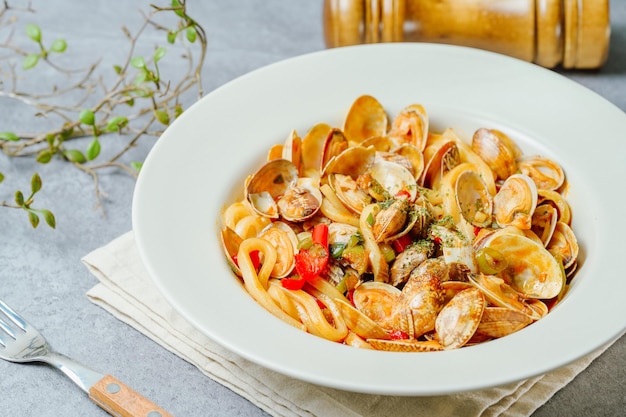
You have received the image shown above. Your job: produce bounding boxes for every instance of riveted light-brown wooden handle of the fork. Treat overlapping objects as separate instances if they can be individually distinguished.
[89,375,173,417]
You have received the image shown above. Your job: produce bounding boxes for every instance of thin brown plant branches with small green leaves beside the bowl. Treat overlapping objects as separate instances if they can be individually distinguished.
[0,0,207,227]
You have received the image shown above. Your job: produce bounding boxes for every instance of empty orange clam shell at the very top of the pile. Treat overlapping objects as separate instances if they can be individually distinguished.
[343,95,389,143]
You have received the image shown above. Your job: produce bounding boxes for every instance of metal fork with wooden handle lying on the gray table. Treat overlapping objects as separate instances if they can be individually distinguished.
[0,300,172,417]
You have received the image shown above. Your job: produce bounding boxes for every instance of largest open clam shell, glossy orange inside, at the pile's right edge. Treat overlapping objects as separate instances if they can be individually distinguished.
[487,234,563,299]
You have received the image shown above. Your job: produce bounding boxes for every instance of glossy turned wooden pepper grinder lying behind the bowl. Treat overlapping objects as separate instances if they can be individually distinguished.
[324,0,610,69]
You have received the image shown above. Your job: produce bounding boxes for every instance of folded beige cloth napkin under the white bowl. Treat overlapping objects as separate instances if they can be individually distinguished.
[83,231,608,417]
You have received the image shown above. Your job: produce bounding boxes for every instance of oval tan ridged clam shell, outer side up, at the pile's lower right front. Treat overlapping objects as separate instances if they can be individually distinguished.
[435,288,485,349]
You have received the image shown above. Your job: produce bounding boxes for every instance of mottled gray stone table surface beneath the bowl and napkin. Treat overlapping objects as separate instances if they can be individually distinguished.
[0,0,626,417]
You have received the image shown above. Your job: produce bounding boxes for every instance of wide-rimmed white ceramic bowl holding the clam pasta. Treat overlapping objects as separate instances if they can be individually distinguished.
[133,44,626,395]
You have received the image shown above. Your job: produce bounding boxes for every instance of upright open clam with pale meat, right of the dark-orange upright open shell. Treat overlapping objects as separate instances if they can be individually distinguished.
[493,174,537,229]
